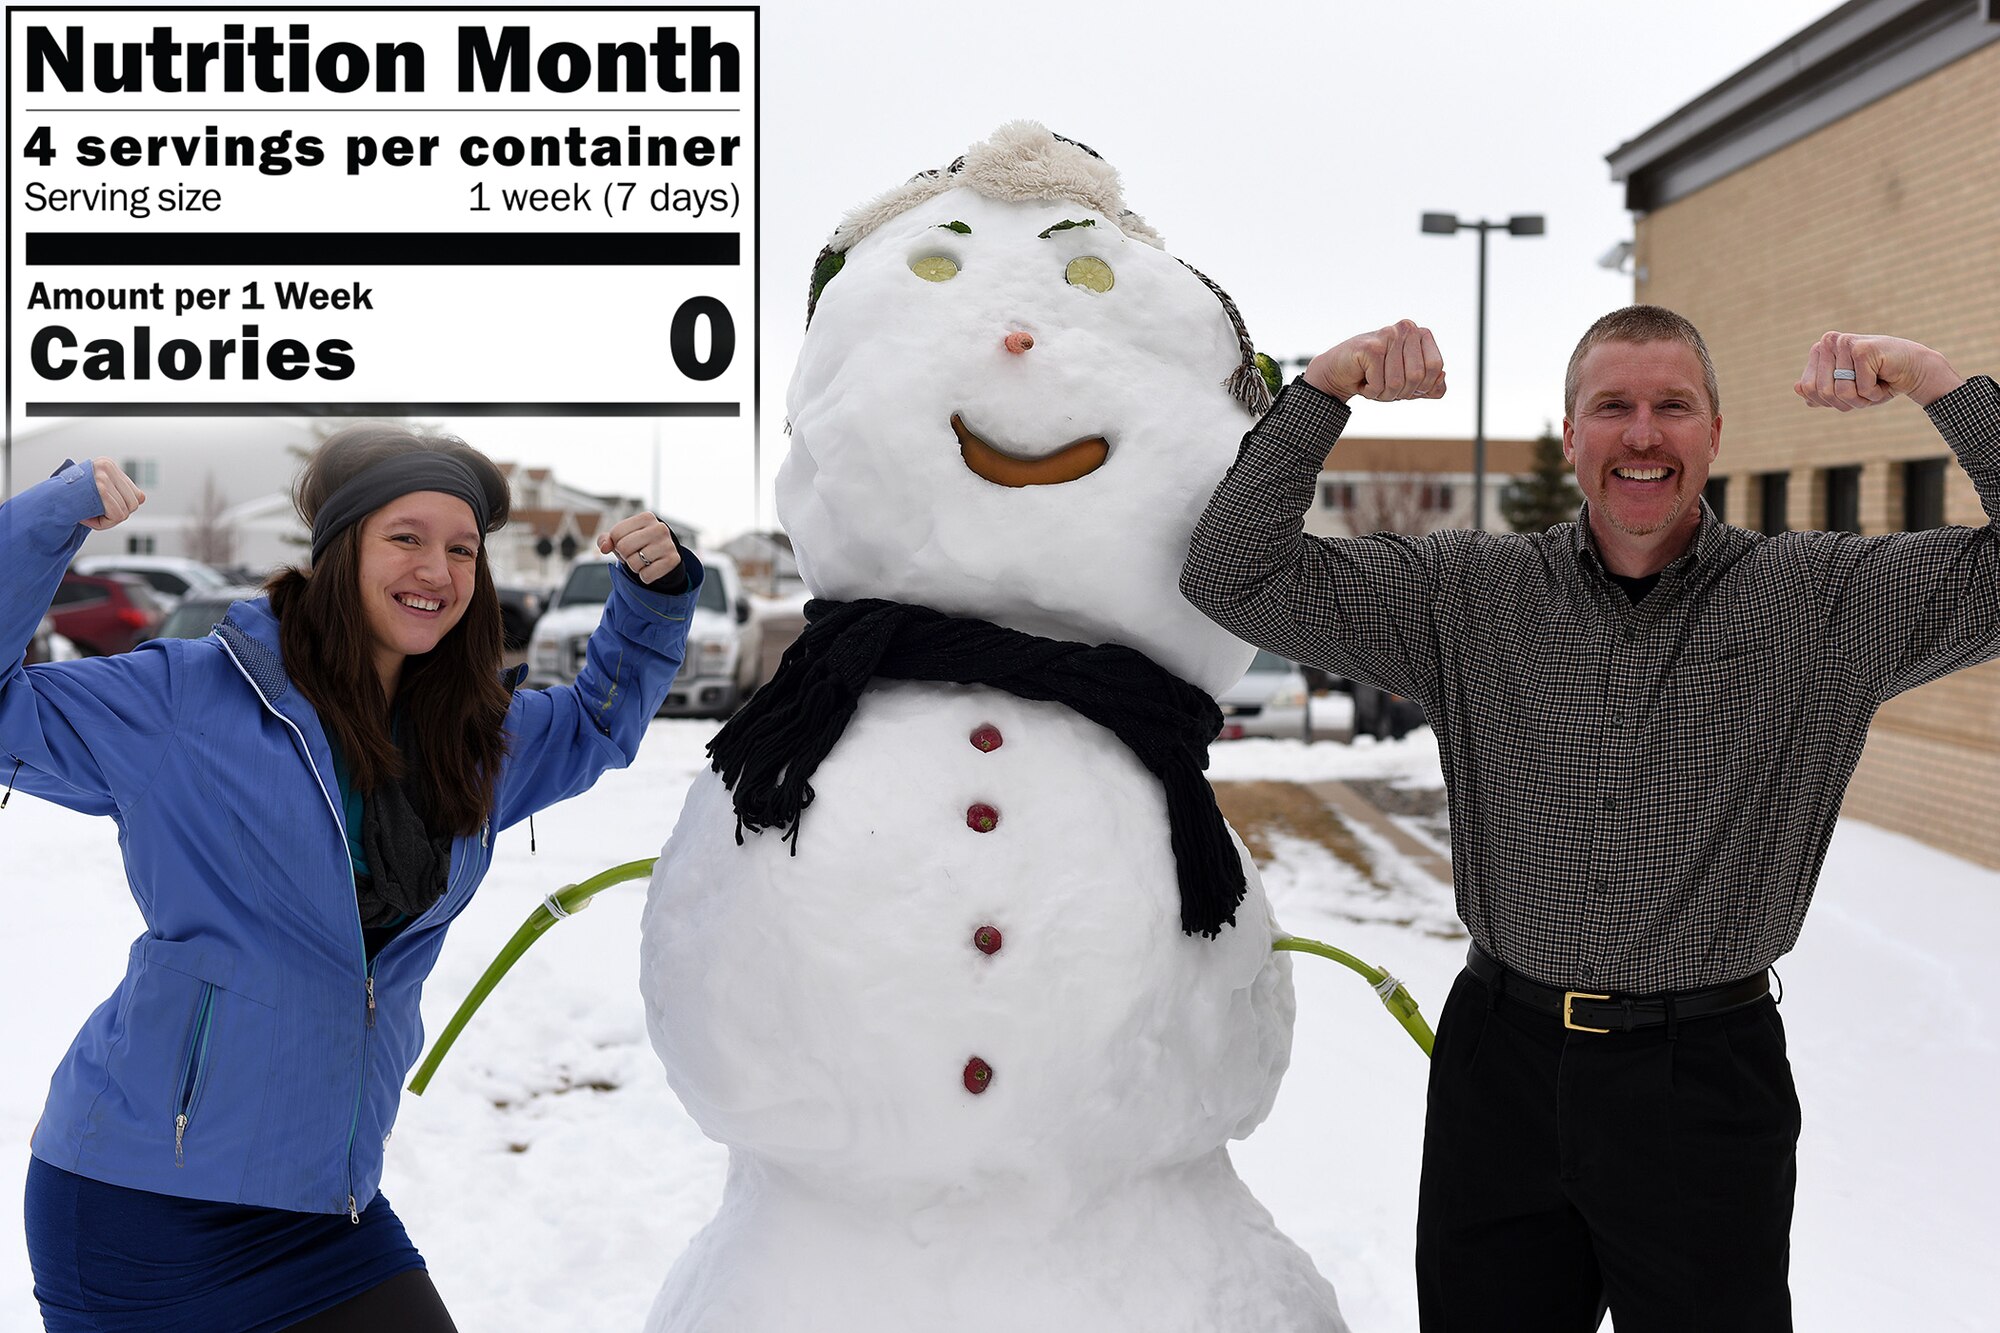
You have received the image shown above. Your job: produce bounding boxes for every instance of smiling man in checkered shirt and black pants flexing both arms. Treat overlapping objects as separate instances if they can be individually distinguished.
[1182,306,2000,1333]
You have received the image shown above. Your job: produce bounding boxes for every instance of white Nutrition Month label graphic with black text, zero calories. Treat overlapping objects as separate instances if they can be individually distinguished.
[6,6,758,428]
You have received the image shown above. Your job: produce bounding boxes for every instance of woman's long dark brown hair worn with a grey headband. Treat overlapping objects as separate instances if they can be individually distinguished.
[264,422,508,833]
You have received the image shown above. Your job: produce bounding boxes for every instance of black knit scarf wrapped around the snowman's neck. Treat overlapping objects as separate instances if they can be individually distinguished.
[708,598,1244,939]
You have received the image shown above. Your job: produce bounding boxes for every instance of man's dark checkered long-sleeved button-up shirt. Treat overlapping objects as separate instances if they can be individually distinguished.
[1182,376,2000,993]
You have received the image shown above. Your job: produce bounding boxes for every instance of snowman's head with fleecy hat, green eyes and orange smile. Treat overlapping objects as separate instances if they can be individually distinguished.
[778,122,1268,693]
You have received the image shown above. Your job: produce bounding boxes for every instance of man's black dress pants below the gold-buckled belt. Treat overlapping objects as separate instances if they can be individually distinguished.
[1416,973,1798,1333]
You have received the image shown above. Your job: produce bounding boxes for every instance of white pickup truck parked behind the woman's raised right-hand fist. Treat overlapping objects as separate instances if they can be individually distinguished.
[528,552,762,717]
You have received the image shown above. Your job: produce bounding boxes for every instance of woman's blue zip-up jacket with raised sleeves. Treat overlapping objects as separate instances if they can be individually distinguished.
[0,464,702,1213]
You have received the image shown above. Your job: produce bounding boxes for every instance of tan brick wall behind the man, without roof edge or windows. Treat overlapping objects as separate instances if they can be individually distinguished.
[1636,44,2000,867]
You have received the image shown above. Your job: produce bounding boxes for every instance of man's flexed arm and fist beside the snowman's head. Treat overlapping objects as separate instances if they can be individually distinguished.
[1180,320,1450,697]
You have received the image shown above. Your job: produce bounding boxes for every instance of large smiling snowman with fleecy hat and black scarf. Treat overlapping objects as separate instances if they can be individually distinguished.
[642,122,1344,1333]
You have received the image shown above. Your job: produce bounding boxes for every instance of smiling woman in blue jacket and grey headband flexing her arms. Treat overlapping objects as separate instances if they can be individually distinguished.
[0,424,702,1333]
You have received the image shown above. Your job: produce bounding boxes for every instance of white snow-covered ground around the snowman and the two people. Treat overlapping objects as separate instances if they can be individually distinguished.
[0,721,2000,1333]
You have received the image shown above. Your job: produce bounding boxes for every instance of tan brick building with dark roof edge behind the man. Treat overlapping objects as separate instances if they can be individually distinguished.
[1610,0,2000,867]
